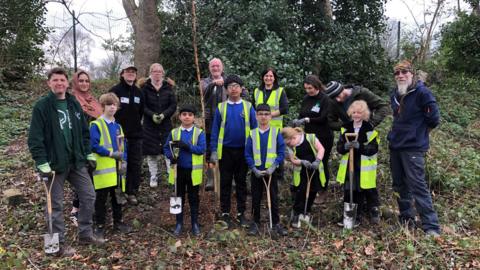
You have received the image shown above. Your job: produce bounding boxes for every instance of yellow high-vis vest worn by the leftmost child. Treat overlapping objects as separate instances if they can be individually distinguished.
[90,118,123,190]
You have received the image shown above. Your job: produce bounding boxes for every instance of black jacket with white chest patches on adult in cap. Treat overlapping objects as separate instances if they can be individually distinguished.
[109,78,144,139]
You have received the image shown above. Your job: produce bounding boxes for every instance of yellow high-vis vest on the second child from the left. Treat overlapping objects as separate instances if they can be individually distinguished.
[168,127,203,186]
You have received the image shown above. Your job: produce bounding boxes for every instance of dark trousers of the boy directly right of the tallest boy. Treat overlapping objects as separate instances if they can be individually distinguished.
[251,170,280,225]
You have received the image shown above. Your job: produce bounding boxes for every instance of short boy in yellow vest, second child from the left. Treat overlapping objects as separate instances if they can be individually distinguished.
[163,105,207,236]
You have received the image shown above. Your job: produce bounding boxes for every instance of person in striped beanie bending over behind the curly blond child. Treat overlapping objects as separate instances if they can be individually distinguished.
[325,81,390,131]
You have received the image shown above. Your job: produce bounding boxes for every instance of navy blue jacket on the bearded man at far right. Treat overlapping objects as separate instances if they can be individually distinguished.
[388,81,440,152]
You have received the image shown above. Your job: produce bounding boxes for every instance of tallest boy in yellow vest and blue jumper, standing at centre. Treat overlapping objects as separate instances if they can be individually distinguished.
[210,75,257,228]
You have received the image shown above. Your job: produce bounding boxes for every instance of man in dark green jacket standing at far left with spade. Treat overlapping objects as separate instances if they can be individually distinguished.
[28,68,101,256]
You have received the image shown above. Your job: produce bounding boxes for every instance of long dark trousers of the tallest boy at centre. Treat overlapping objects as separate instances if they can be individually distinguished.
[219,146,248,214]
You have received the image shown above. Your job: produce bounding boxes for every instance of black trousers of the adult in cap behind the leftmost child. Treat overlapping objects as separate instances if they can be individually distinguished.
[125,139,142,195]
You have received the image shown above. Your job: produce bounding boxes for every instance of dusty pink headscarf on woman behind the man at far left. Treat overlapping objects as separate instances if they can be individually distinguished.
[72,70,102,119]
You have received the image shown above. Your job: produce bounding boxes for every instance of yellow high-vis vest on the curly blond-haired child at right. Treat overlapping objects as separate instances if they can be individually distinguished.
[337,128,380,189]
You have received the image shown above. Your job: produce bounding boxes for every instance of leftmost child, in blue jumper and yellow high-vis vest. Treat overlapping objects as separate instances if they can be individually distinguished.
[90,93,131,239]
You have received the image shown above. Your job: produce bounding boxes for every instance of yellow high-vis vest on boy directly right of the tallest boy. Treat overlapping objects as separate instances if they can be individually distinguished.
[250,127,278,168]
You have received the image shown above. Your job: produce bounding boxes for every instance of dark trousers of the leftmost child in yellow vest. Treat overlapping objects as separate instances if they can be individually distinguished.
[95,187,122,225]
